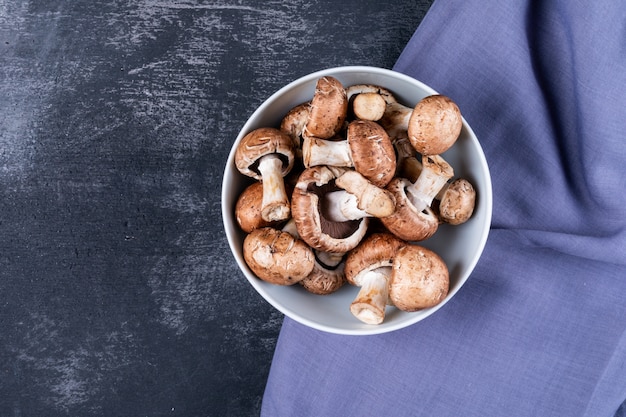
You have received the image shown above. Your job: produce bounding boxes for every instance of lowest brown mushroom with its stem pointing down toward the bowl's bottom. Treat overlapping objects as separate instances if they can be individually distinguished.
[345,233,407,324]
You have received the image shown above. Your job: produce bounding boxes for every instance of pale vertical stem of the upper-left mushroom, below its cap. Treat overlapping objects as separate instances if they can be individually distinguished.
[258,154,290,222]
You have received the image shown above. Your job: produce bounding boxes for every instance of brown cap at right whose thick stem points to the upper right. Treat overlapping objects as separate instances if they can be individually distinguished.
[380,177,439,241]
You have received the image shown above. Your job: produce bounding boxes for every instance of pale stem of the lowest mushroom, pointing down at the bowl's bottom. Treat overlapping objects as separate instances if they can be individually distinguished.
[350,266,391,324]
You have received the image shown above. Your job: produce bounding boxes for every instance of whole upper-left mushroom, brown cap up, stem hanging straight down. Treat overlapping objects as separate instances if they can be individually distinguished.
[235,127,294,221]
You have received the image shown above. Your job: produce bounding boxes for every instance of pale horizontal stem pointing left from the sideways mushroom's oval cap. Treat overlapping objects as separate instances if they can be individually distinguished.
[302,136,354,168]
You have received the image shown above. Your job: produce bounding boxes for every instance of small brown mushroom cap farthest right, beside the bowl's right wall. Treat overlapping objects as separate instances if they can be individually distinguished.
[438,178,476,225]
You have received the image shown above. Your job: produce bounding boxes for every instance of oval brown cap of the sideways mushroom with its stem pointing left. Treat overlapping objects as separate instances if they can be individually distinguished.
[346,120,396,187]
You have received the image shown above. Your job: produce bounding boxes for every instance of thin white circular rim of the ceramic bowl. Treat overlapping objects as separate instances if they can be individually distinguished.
[221,65,493,336]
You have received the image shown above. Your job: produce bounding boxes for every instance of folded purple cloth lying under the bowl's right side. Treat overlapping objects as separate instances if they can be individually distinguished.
[262,0,626,417]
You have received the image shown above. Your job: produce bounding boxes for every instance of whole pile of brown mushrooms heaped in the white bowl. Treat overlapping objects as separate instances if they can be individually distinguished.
[235,76,476,324]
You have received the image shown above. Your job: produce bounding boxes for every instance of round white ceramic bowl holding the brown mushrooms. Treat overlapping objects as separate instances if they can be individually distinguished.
[222,66,492,335]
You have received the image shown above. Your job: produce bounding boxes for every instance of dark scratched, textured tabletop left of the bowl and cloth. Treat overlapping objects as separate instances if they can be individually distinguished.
[0,0,430,416]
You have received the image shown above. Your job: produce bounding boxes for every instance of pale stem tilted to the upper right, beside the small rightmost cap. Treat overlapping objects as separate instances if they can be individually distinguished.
[406,155,454,211]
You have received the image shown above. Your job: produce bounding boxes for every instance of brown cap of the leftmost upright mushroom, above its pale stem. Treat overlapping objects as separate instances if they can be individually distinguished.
[235,127,294,180]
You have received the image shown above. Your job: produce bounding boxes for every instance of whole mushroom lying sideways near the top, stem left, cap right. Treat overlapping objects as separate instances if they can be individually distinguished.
[302,120,396,187]
